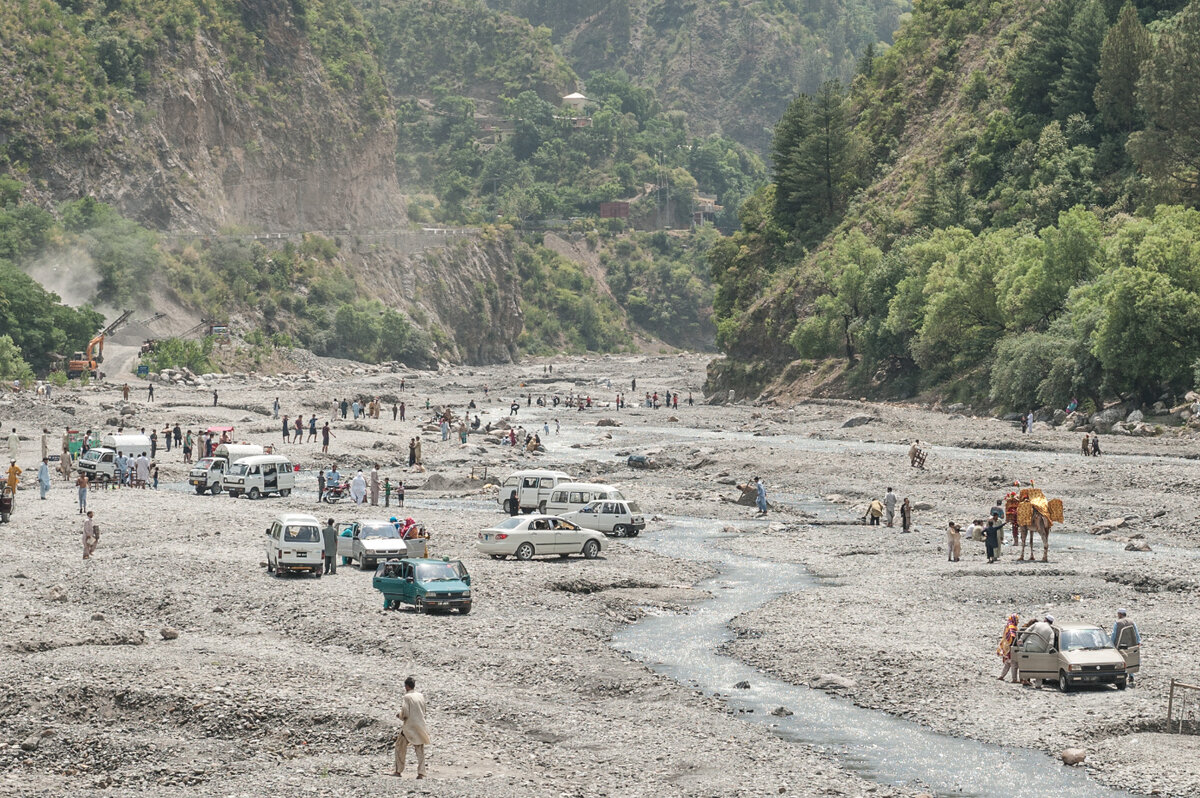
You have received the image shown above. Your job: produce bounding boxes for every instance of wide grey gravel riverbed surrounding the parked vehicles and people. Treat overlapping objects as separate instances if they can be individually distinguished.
[0,356,1200,796]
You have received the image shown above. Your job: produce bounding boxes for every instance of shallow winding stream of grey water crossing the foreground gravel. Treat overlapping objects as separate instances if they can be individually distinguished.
[613,518,1127,798]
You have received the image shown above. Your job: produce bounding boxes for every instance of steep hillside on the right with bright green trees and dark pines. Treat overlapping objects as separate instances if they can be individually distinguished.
[712,0,1200,408]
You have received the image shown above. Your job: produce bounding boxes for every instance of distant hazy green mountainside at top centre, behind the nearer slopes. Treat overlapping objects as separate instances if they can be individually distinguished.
[488,0,910,152]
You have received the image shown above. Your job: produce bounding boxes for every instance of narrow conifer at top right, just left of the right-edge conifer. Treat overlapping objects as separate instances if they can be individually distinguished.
[1094,2,1151,133]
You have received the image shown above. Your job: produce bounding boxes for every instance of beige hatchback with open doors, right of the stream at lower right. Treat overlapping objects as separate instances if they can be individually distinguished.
[1016,624,1141,692]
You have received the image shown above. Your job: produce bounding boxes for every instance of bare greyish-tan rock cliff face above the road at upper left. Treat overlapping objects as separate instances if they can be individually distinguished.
[32,0,404,233]
